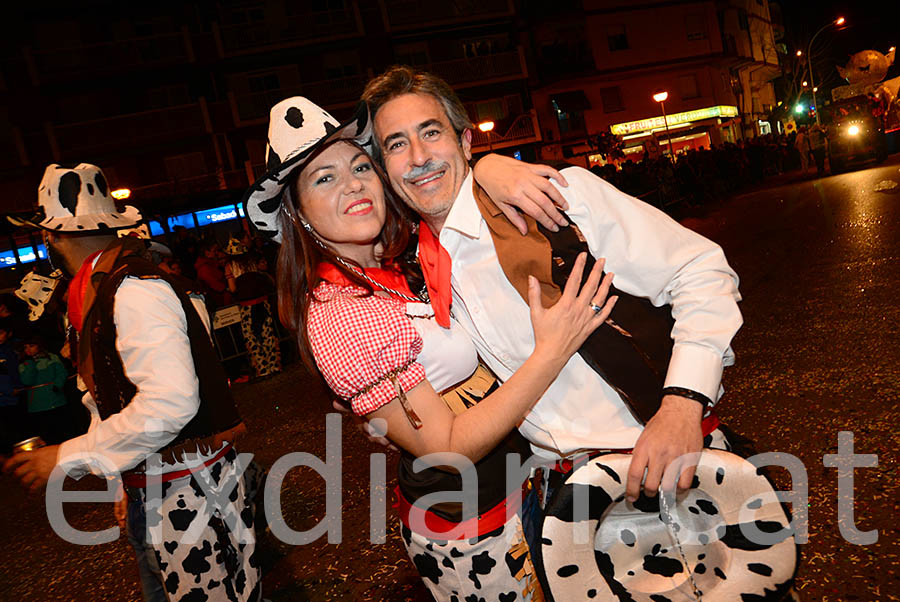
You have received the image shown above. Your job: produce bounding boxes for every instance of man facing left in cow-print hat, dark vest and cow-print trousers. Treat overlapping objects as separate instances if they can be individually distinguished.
[4,164,261,602]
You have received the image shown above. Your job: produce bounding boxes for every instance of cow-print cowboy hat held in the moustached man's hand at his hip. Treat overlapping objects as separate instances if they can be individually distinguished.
[533,449,797,602]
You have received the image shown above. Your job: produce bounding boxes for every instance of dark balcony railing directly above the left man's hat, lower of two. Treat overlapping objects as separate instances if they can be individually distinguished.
[47,102,209,158]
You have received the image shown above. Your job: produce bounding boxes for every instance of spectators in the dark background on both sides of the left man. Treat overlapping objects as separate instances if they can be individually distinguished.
[0,228,281,454]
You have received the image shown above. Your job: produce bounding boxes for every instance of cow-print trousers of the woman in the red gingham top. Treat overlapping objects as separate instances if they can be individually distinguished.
[401,508,542,602]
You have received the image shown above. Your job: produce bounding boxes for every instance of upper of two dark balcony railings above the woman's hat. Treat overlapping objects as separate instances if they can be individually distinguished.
[216,5,363,54]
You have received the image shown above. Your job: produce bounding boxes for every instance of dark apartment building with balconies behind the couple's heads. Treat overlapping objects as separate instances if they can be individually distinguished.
[0,0,539,218]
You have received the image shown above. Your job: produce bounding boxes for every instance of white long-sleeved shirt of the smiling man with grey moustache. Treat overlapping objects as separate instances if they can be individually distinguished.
[440,167,742,457]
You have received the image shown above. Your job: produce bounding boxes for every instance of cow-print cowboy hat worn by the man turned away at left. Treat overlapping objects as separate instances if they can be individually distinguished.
[9,163,141,232]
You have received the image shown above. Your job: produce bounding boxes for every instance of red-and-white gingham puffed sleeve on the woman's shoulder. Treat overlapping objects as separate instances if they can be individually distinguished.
[307,282,425,416]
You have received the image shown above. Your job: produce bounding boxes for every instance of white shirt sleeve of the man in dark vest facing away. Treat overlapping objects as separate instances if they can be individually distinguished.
[58,278,218,478]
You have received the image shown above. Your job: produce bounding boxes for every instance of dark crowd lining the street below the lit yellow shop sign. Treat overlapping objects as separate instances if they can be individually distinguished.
[591,132,801,208]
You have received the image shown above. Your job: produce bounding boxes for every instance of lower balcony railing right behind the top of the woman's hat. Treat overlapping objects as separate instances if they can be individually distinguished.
[233,75,369,124]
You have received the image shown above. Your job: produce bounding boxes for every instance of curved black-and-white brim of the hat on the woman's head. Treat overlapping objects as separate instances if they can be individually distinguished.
[244,102,372,243]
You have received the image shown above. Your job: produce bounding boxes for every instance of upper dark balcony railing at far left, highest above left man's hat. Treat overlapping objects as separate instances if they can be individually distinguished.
[25,32,193,84]
